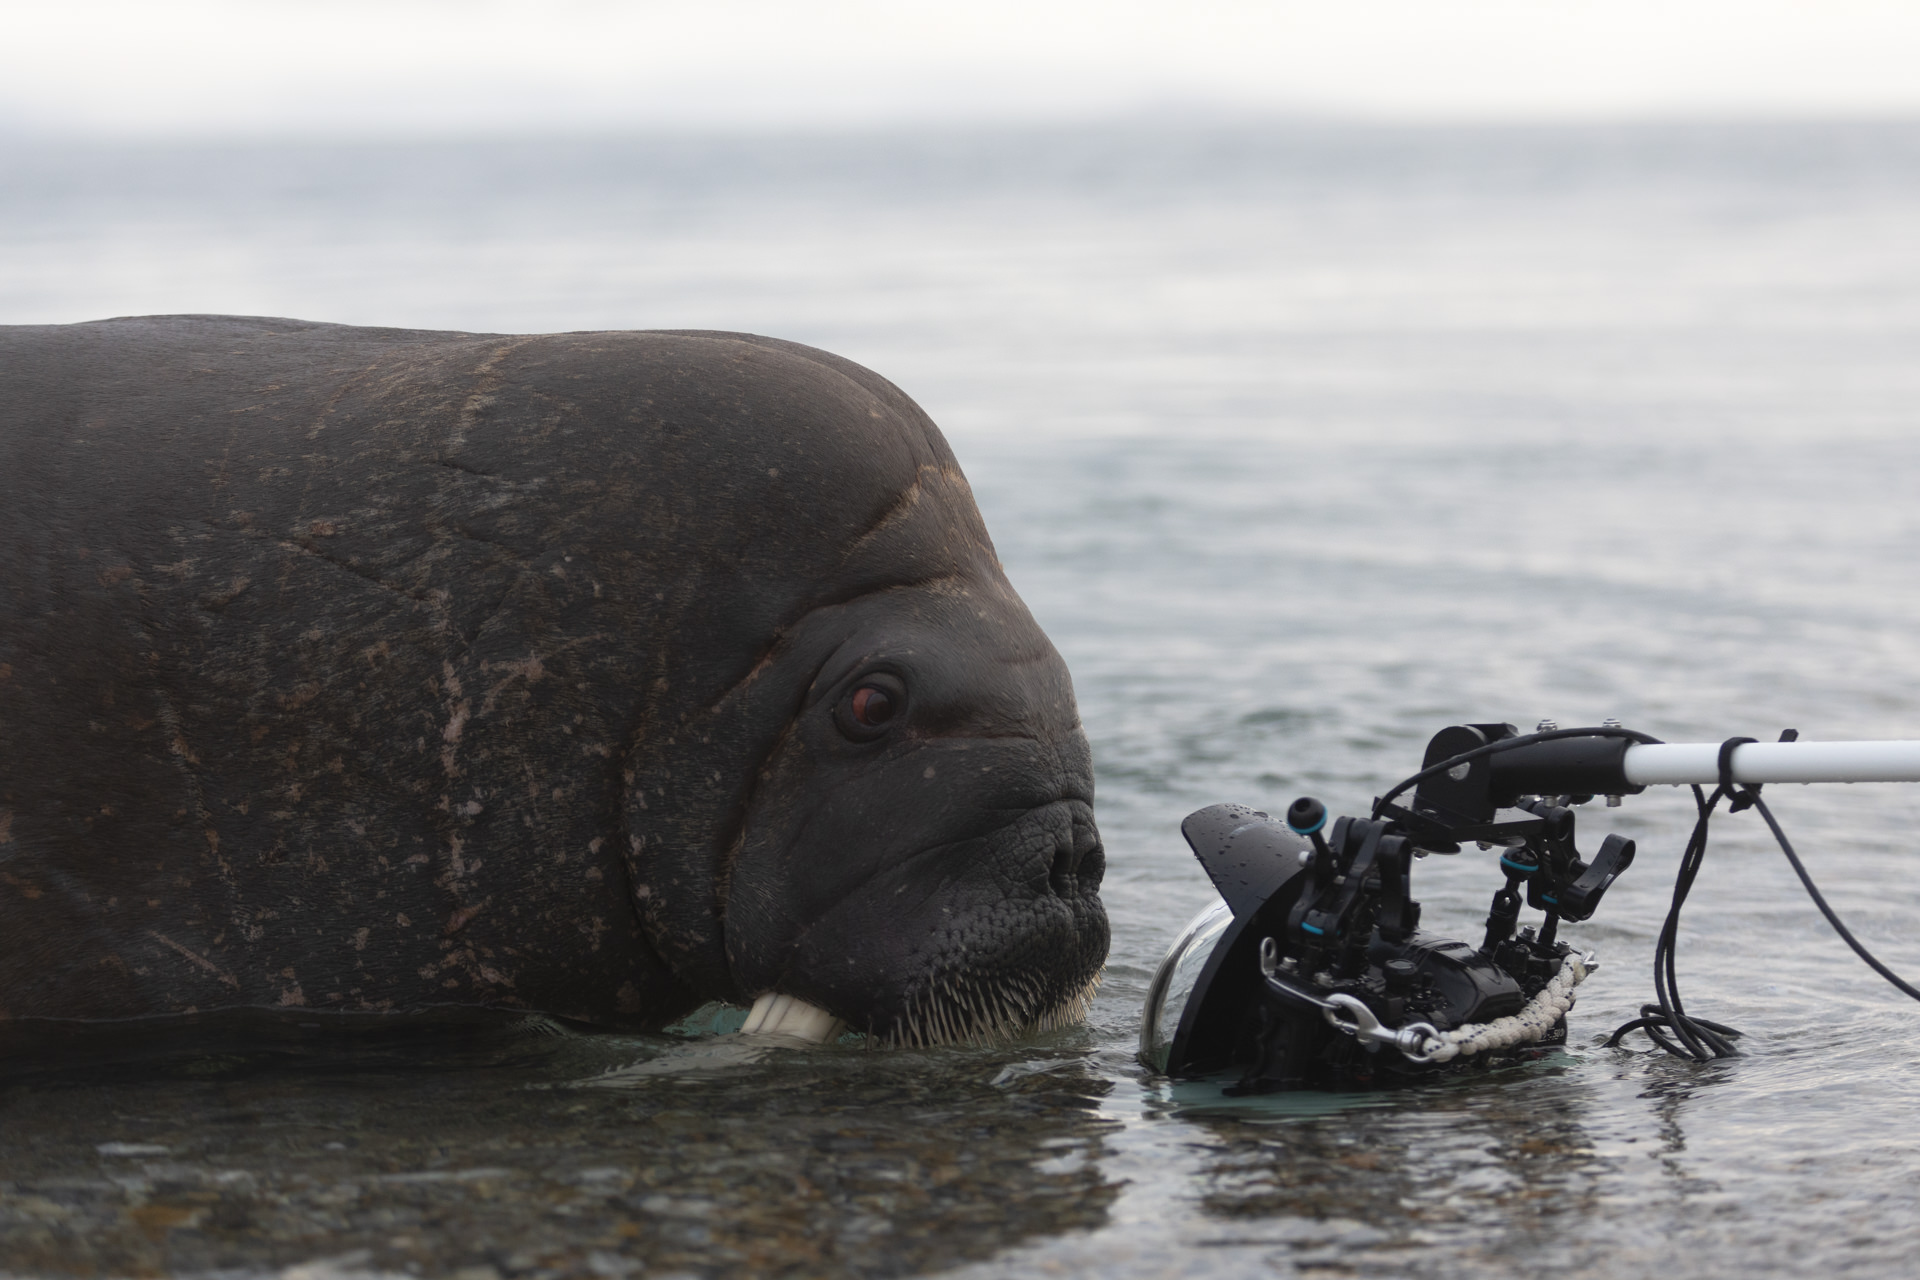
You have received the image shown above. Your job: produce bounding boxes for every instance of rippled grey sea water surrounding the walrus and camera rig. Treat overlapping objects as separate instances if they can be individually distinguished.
[0,125,1920,1280]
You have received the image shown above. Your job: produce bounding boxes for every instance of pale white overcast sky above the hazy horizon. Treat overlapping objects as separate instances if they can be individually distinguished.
[0,0,1920,134]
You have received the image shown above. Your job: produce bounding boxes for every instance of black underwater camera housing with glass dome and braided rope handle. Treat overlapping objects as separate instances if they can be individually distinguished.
[1140,723,1647,1094]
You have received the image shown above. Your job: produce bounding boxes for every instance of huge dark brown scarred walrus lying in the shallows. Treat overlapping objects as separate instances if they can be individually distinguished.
[0,317,1108,1044]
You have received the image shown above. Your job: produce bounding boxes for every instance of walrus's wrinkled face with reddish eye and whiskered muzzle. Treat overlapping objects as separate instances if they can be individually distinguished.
[724,556,1108,1042]
